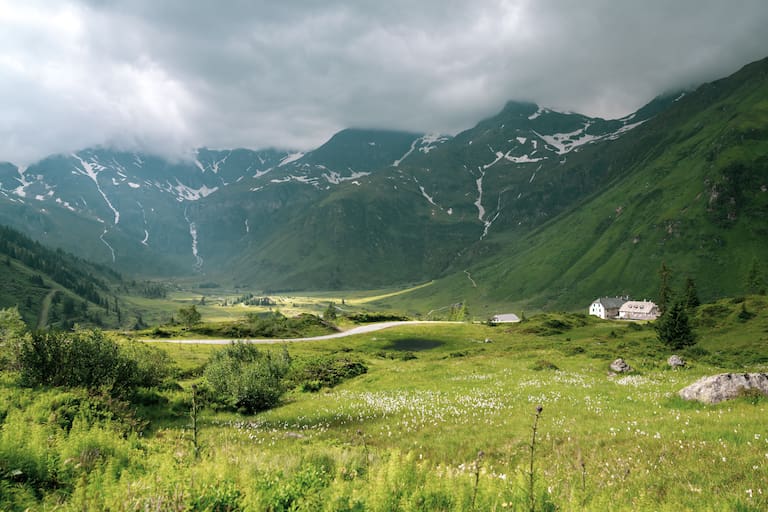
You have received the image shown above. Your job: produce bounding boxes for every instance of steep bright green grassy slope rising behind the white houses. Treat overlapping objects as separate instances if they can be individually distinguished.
[392,55,768,309]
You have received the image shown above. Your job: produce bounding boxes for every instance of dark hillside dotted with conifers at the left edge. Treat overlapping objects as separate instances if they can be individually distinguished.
[0,226,127,328]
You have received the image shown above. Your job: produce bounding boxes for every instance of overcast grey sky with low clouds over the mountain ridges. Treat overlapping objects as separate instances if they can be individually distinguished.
[0,0,768,164]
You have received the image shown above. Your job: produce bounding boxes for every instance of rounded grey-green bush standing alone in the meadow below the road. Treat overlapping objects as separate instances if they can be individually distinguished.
[204,342,291,414]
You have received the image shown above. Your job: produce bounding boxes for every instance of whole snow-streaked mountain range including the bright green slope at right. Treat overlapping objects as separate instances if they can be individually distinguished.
[0,54,768,309]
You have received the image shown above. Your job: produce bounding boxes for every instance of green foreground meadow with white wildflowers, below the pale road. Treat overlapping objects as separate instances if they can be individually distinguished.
[0,296,768,511]
